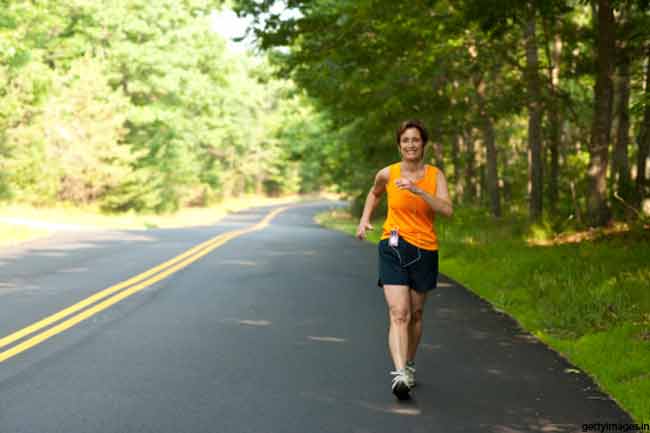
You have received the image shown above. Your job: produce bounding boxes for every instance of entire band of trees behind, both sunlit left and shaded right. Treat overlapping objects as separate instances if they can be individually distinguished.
[0,0,650,230]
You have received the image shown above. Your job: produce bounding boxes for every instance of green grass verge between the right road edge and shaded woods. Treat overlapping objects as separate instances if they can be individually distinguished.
[317,206,650,423]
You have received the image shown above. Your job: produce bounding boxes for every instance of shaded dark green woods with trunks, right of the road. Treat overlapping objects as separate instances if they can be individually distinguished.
[236,0,650,230]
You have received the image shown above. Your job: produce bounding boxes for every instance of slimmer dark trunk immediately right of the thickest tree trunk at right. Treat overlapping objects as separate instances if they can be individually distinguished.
[612,4,632,211]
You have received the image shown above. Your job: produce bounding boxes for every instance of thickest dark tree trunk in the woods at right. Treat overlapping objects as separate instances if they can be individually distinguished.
[587,0,615,226]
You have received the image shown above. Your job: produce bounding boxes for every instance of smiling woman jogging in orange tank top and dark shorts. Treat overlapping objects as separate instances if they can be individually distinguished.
[357,120,453,400]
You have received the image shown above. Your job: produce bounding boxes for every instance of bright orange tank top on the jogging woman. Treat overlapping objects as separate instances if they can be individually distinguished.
[381,162,438,251]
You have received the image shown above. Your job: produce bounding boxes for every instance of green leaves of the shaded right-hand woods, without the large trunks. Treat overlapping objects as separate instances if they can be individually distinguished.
[235,0,650,228]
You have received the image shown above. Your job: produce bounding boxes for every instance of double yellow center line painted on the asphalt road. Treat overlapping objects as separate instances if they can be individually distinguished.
[0,207,287,362]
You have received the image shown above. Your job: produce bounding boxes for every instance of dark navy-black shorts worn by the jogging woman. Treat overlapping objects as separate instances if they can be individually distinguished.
[377,238,438,293]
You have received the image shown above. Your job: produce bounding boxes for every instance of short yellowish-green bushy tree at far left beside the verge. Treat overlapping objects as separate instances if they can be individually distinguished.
[6,57,133,204]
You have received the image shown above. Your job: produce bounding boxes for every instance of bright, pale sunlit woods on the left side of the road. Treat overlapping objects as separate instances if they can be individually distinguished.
[0,0,330,212]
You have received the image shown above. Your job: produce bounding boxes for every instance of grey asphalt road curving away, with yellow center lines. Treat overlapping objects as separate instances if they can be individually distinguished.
[0,203,631,433]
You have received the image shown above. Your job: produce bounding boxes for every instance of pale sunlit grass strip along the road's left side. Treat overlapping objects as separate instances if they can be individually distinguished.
[0,195,330,246]
